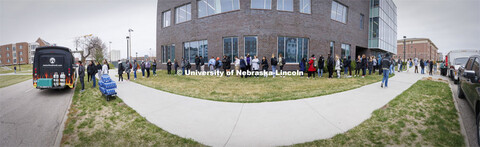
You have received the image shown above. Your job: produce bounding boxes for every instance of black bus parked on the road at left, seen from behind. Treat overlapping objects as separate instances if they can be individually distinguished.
[32,46,77,89]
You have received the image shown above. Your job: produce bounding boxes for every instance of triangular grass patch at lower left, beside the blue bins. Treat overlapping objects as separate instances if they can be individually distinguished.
[61,78,203,146]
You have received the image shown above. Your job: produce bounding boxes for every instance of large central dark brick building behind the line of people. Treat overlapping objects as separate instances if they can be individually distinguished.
[156,0,396,69]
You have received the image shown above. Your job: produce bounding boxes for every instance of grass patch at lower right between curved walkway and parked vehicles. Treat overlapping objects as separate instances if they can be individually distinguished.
[295,80,465,146]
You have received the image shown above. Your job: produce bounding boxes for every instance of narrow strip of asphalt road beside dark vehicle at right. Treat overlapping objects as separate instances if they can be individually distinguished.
[449,80,478,147]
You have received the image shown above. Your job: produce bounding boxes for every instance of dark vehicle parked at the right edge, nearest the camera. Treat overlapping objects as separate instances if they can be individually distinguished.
[458,55,480,144]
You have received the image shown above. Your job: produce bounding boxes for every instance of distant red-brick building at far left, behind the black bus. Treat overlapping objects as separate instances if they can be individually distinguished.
[0,38,50,65]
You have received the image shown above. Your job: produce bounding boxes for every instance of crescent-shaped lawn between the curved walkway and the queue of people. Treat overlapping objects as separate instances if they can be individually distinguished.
[131,70,390,103]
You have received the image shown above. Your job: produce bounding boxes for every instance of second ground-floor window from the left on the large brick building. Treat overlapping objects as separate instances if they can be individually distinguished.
[183,40,208,63]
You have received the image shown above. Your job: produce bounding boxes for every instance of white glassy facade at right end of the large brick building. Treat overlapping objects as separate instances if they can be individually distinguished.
[368,0,397,56]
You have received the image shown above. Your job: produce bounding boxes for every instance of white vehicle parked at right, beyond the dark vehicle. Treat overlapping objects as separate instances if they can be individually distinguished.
[445,50,480,84]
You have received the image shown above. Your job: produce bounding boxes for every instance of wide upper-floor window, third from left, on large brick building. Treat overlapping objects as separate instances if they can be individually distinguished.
[198,0,240,17]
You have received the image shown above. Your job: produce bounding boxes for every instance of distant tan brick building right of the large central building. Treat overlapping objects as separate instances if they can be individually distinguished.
[397,38,440,61]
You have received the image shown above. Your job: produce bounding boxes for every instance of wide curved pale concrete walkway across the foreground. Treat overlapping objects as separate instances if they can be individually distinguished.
[110,70,426,146]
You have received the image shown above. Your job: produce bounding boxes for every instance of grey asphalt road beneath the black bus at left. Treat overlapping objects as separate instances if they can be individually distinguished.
[0,80,74,147]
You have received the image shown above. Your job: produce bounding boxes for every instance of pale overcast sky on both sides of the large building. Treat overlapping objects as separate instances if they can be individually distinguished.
[0,0,480,57]
